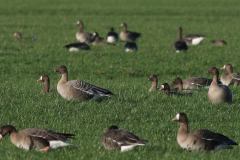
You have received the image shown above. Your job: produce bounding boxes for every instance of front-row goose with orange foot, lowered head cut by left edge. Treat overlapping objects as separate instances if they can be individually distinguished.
[0,125,75,152]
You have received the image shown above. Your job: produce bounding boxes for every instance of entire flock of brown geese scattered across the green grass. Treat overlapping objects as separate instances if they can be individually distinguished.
[0,21,237,152]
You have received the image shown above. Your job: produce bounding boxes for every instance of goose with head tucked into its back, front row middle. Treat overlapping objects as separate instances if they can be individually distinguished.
[101,125,148,152]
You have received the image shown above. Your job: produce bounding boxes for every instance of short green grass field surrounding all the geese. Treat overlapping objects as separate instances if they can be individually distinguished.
[0,0,240,160]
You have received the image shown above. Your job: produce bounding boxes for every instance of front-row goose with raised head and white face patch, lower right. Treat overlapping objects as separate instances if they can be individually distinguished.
[172,113,238,151]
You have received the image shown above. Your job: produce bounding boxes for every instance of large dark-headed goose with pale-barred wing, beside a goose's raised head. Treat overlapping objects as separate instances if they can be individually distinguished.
[54,65,113,100]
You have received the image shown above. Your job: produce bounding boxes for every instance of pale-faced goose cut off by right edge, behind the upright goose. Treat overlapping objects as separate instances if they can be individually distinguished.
[221,64,240,86]
